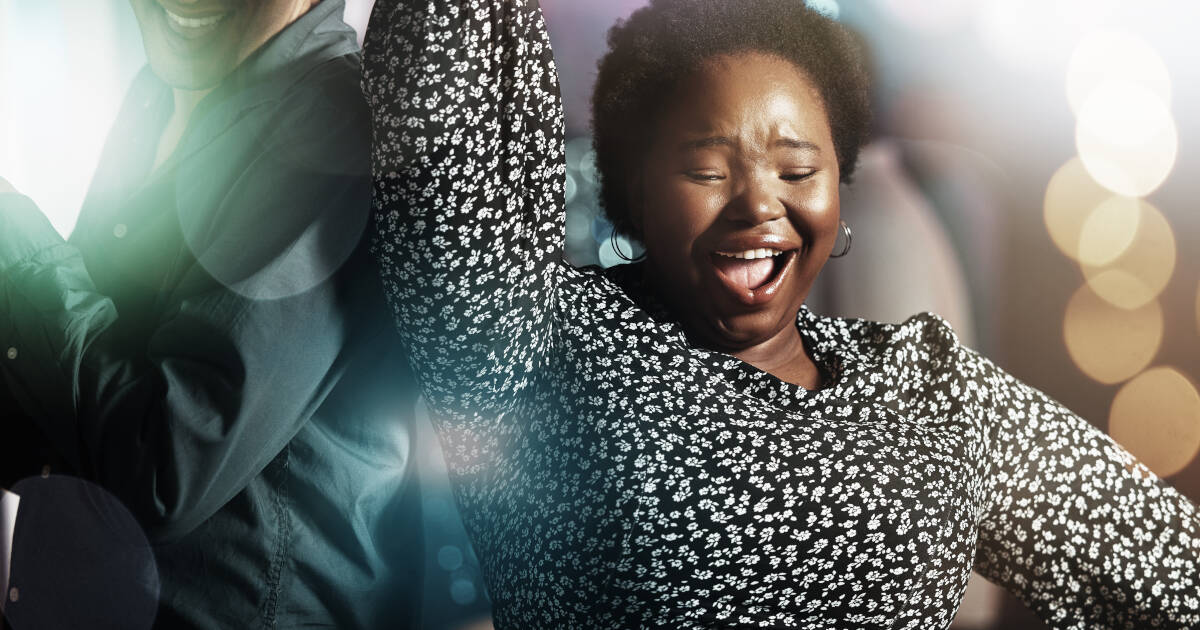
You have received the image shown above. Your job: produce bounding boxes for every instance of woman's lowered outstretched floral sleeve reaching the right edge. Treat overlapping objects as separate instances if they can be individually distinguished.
[964,350,1200,630]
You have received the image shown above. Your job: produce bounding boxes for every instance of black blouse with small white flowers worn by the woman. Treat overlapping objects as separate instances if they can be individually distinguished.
[365,0,1200,630]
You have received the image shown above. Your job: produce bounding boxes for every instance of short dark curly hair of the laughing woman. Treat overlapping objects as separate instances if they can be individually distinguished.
[592,0,871,238]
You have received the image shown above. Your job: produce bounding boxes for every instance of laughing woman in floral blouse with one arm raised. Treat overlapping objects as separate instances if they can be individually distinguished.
[365,0,1200,629]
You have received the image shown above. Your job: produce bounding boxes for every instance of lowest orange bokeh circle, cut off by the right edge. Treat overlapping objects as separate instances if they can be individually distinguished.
[1109,367,1200,476]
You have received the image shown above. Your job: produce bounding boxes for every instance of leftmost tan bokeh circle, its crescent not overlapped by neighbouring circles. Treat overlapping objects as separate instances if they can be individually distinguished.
[1043,157,1138,260]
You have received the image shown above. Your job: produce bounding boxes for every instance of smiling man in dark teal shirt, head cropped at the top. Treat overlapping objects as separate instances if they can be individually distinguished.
[0,0,422,630]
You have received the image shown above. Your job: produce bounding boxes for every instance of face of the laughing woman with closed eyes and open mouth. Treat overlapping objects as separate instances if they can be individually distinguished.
[631,53,839,353]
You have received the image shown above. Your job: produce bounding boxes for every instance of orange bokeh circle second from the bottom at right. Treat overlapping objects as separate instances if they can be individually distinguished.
[1062,284,1163,384]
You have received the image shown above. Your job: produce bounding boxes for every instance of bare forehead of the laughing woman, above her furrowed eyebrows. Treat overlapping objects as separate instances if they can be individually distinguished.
[661,52,832,143]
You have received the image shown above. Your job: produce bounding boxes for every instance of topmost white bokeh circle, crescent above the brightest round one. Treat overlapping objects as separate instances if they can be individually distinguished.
[1067,31,1171,114]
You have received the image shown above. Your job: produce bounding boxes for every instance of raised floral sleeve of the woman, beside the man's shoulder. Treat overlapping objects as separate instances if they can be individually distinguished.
[364,0,565,418]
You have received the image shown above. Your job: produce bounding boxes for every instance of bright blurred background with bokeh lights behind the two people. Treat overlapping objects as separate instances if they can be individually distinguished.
[0,0,1200,630]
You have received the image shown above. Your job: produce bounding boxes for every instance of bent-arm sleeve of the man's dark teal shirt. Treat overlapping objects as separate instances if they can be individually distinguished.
[0,73,370,541]
